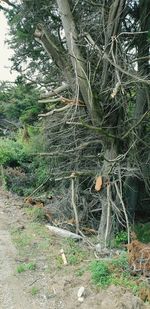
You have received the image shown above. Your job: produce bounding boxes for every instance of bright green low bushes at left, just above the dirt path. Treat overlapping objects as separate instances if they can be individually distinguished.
[0,126,49,196]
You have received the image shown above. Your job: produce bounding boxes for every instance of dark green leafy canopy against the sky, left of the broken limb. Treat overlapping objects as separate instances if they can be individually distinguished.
[6,0,59,80]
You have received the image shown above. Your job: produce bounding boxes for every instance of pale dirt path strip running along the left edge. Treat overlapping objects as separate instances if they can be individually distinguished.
[0,191,40,309]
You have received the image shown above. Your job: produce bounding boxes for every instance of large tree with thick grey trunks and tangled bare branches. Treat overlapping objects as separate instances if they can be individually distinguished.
[0,0,150,245]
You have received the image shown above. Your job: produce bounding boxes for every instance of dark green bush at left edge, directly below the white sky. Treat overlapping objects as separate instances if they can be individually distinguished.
[0,81,43,124]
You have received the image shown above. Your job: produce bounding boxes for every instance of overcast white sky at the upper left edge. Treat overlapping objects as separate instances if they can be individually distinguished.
[0,11,17,81]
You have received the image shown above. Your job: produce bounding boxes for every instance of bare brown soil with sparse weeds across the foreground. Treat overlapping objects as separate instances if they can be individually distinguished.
[0,190,150,309]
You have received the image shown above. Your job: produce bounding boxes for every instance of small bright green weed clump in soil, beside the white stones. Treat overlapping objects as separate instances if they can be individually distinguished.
[90,261,111,287]
